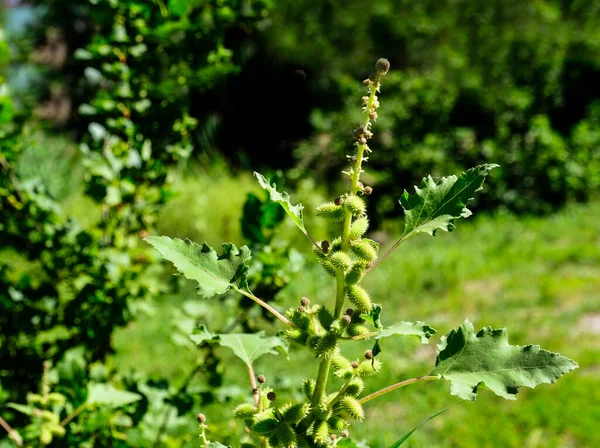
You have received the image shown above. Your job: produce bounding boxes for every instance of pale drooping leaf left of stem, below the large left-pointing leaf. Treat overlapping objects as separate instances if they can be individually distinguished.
[190,326,288,366]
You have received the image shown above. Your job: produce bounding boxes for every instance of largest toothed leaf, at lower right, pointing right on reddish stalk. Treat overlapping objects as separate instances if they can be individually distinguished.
[431,320,578,400]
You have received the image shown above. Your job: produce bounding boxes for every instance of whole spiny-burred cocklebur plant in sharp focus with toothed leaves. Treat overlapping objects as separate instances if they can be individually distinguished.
[147,59,577,448]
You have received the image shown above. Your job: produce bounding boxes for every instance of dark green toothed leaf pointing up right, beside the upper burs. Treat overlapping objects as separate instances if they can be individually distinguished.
[400,164,498,236]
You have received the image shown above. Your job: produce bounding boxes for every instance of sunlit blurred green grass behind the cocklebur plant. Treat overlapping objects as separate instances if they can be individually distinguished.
[115,203,600,448]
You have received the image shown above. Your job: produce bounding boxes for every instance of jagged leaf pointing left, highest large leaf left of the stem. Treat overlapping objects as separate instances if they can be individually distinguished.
[145,236,252,299]
